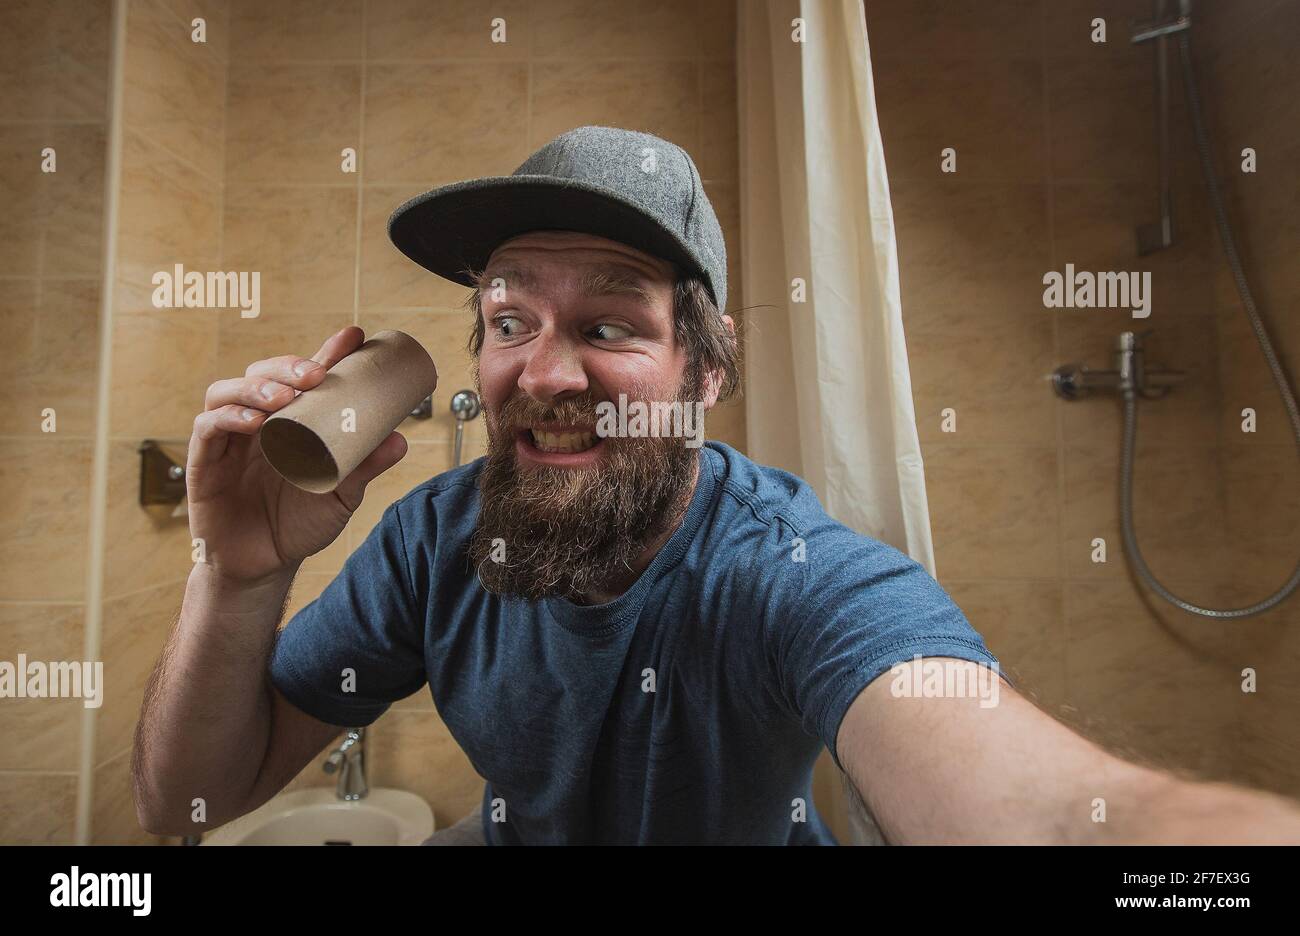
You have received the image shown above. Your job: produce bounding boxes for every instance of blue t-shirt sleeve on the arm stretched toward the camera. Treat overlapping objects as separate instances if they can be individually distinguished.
[764,527,1001,768]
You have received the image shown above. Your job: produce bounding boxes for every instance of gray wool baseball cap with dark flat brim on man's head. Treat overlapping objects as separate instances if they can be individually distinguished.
[389,126,727,312]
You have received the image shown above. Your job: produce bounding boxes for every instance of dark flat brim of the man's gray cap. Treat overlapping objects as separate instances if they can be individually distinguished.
[389,174,696,296]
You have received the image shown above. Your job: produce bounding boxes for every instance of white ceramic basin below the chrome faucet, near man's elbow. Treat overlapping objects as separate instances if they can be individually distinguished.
[202,787,434,845]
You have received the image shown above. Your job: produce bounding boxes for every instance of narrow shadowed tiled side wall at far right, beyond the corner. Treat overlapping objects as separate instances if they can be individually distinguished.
[1200,0,1300,796]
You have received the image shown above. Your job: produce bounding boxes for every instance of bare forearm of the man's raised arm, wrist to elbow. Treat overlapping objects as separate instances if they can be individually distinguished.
[133,563,294,828]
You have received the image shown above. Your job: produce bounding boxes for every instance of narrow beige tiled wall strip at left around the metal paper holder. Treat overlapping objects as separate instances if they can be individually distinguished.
[87,0,228,844]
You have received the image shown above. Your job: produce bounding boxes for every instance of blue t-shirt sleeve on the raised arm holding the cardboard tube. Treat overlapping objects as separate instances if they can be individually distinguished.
[270,503,426,728]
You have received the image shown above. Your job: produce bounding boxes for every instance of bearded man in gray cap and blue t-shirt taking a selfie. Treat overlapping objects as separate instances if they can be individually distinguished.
[134,127,1300,845]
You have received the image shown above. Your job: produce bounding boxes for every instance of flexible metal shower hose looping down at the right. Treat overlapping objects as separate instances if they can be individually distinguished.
[1119,33,1300,619]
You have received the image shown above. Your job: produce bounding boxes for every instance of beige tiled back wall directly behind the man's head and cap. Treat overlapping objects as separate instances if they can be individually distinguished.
[217,0,745,826]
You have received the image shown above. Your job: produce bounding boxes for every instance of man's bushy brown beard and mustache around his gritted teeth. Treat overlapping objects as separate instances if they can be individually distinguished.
[469,373,701,603]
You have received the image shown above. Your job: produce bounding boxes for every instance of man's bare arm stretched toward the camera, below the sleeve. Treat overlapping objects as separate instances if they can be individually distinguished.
[836,658,1300,845]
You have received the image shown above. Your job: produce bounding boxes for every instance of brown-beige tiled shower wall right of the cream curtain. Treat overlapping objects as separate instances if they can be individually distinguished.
[866,0,1300,794]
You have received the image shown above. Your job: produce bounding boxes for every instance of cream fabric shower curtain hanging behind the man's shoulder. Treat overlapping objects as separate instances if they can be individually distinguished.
[737,0,935,842]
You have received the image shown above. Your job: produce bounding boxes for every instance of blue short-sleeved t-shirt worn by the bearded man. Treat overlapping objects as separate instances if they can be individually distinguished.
[270,442,996,845]
